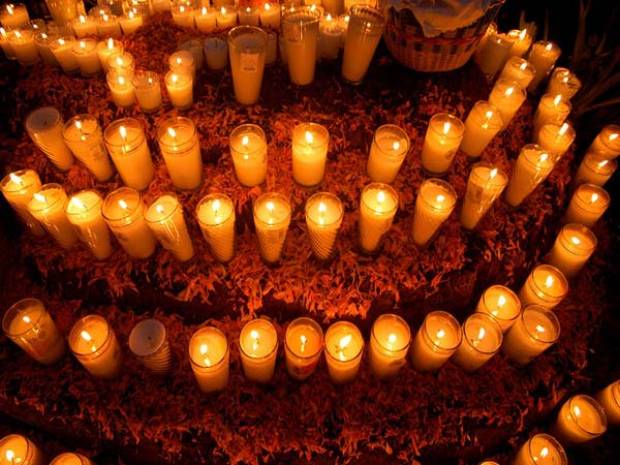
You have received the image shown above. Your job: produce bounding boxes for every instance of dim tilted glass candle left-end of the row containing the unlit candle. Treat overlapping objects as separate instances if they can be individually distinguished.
[2,297,65,365]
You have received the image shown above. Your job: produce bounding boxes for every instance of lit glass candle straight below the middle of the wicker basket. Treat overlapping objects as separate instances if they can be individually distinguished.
[422,113,465,174]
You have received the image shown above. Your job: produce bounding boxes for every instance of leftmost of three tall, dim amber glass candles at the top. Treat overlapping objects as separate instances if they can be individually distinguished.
[228,26,267,105]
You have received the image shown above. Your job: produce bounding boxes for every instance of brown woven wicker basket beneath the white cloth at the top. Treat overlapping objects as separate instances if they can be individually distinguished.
[382,0,504,72]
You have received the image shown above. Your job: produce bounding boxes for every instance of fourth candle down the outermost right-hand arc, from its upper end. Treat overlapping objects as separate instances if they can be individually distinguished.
[549,223,597,279]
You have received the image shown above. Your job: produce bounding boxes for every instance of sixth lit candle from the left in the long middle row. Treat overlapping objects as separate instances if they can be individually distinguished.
[196,194,235,262]
